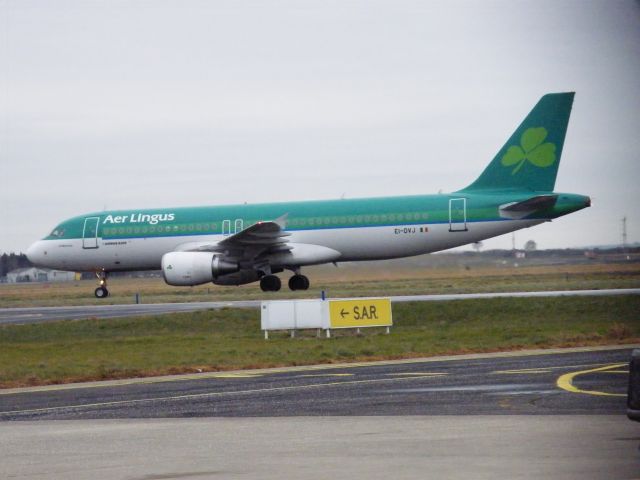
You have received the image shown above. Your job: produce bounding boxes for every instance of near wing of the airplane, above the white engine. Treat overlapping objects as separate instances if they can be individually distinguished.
[177,215,291,261]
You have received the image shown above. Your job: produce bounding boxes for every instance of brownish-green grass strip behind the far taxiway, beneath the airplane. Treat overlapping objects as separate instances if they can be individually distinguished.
[0,262,640,308]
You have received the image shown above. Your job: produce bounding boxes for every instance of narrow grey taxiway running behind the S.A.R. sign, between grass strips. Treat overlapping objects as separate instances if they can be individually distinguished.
[0,288,640,325]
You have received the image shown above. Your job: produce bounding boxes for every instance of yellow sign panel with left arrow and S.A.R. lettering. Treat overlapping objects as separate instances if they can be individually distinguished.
[329,298,393,328]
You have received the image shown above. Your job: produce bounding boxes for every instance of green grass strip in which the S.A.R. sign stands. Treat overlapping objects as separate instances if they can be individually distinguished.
[0,295,640,387]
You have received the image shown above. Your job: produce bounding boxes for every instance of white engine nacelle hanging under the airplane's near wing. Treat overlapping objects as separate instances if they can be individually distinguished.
[162,252,240,286]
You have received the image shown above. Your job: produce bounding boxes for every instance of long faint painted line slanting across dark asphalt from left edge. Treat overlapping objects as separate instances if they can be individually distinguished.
[0,377,444,415]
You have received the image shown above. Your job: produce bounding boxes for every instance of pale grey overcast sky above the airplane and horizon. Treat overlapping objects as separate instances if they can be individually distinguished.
[0,0,640,252]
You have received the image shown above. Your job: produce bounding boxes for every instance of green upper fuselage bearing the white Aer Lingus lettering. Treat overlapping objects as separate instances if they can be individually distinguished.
[45,191,586,240]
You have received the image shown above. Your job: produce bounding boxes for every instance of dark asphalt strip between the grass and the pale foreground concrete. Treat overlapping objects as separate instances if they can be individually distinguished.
[0,346,631,420]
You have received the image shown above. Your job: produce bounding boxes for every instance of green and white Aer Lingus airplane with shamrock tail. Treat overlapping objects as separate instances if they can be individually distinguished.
[26,92,591,298]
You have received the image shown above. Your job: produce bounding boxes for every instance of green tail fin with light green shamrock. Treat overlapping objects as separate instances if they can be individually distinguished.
[462,92,574,192]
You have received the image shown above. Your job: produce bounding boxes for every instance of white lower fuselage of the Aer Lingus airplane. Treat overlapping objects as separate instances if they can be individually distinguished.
[27,220,543,271]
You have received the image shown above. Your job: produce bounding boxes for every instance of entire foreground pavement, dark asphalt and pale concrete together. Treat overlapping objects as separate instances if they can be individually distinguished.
[0,346,640,480]
